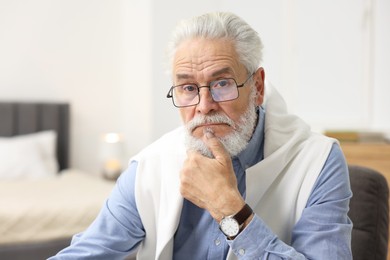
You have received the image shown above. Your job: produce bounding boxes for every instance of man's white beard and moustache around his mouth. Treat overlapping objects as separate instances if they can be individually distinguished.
[185,90,257,158]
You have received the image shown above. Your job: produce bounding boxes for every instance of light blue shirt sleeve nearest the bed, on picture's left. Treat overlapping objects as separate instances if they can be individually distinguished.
[49,162,145,260]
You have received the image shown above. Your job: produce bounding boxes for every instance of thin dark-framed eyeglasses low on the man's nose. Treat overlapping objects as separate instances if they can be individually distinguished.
[167,73,253,108]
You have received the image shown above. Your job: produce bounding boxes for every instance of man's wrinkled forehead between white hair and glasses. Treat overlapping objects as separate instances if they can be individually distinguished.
[172,38,243,80]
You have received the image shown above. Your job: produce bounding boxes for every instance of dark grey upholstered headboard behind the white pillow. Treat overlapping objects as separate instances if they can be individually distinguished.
[0,102,69,170]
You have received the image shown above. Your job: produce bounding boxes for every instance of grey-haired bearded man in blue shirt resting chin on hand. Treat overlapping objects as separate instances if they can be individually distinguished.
[53,13,352,259]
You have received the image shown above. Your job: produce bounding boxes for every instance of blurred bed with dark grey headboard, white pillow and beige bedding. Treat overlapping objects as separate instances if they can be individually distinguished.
[0,102,114,260]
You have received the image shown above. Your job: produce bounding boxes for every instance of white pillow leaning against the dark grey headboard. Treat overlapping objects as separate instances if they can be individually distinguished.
[0,130,59,179]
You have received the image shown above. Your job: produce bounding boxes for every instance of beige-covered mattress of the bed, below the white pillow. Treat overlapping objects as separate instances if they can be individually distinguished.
[0,170,115,245]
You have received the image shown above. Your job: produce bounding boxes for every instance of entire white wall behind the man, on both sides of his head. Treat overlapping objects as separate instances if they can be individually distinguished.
[0,0,390,175]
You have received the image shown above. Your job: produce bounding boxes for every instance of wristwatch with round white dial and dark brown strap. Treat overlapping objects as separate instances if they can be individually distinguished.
[219,204,253,239]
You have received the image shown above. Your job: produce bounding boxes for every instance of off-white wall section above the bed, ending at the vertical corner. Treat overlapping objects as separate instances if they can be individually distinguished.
[0,0,151,173]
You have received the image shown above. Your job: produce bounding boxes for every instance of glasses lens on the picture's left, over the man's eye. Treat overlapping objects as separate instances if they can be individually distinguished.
[173,84,199,107]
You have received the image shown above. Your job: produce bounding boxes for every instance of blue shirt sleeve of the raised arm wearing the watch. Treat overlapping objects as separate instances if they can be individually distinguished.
[228,144,352,260]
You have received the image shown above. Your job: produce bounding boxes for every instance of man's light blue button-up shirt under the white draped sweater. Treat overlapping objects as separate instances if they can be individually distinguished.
[50,109,352,260]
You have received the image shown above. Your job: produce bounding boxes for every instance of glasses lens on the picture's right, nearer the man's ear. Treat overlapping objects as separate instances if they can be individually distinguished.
[210,79,238,102]
